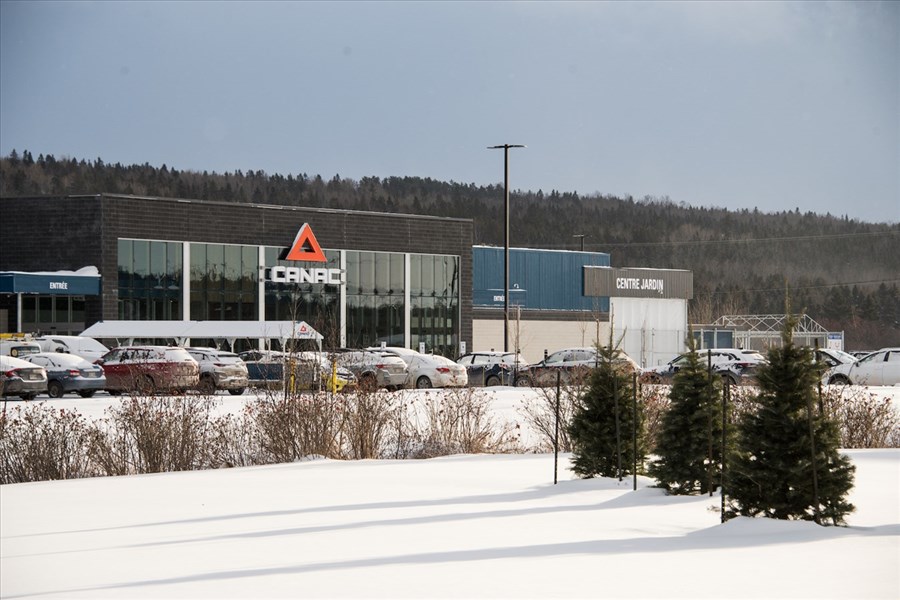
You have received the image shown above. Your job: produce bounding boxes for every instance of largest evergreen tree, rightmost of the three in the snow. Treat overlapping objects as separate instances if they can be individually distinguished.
[725,319,855,525]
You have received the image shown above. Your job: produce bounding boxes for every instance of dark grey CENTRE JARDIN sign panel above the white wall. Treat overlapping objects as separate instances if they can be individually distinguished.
[584,267,694,299]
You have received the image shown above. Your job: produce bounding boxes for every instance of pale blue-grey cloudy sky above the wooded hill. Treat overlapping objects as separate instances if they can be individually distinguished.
[0,0,900,222]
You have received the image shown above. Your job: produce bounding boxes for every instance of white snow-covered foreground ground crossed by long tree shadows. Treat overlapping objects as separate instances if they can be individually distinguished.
[0,389,900,599]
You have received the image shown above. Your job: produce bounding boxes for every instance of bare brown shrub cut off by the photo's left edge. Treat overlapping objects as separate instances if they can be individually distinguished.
[0,404,96,483]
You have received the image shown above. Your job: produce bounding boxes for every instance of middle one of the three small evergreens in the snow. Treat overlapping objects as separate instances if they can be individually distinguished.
[649,336,727,494]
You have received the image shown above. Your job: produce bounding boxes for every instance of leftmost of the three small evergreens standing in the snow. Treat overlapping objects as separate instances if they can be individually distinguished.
[569,336,646,478]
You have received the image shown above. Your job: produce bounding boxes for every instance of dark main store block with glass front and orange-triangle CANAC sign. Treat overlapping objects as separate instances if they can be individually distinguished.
[0,194,473,355]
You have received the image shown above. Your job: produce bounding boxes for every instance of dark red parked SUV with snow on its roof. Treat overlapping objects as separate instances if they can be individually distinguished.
[96,346,200,394]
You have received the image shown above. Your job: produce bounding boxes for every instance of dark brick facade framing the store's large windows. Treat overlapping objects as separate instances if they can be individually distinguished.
[0,194,473,343]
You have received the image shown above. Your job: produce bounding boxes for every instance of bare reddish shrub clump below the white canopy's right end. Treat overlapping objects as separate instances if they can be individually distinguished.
[246,392,346,462]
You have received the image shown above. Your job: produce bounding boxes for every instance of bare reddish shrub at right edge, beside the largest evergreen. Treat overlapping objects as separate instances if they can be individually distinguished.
[822,386,900,448]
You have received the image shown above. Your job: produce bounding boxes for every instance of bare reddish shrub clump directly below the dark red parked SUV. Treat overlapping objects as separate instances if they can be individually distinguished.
[91,396,223,475]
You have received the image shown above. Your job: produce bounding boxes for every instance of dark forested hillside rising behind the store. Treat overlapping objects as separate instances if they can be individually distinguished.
[0,150,900,349]
